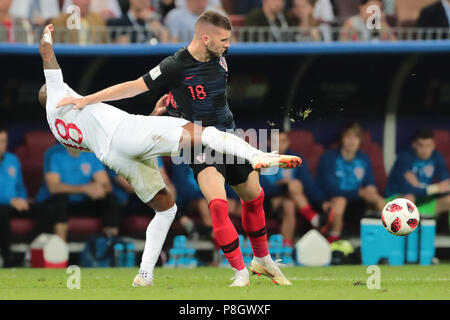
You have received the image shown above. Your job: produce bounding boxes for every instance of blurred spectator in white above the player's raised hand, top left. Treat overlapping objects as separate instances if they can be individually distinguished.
[9,0,60,26]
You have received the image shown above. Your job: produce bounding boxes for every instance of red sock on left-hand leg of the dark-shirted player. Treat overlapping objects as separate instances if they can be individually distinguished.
[209,199,245,270]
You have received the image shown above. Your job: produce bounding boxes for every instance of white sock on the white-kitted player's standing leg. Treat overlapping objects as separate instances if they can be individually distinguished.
[140,205,177,277]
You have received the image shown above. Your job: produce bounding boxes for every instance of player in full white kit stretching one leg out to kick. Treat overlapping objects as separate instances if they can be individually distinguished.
[39,25,302,286]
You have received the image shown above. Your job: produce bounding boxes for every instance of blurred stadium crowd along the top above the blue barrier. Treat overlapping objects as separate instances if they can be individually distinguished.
[0,0,450,44]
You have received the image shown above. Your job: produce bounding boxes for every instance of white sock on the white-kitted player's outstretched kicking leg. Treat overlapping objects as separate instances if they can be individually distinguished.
[202,127,263,161]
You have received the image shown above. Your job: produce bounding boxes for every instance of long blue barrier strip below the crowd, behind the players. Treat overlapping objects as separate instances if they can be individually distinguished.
[0,40,450,56]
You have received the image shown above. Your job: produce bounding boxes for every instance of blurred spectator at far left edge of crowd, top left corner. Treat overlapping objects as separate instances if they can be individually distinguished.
[0,0,33,44]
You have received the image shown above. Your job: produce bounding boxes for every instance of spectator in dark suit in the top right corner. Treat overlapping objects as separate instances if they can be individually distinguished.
[417,0,450,39]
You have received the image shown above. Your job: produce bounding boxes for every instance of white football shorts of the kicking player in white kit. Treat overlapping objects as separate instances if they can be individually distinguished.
[104,115,188,203]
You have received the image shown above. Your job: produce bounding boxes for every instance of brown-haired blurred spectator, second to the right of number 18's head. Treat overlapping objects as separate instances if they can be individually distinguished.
[289,0,321,41]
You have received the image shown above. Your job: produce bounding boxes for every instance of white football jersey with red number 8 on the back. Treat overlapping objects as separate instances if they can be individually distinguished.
[44,69,130,162]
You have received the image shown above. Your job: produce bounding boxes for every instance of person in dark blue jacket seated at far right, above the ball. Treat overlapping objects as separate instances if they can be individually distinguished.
[386,129,450,218]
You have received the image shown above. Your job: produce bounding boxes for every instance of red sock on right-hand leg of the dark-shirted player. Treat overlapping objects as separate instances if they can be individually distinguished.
[241,189,269,258]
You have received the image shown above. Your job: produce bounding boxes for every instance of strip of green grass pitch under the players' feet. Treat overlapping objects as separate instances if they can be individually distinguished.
[0,263,450,300]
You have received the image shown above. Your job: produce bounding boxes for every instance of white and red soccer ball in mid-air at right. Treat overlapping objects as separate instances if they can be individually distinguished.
[381,198,420,236]
